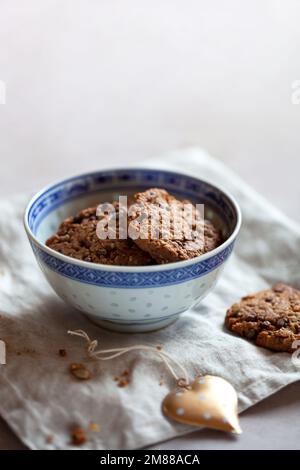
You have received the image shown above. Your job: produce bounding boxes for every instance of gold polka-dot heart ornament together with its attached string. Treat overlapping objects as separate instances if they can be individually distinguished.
[68,330,242,434]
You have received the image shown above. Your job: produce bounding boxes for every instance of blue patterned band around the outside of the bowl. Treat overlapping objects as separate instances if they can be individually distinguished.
[33,242,234,289]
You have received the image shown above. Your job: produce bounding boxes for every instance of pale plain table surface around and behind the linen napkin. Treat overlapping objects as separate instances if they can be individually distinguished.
[0,0,300,449]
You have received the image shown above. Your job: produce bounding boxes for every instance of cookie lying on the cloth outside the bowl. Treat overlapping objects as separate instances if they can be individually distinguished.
[225,283,300,353]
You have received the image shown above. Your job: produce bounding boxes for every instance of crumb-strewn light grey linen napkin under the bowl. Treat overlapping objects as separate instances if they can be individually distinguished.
[0,149,300,449]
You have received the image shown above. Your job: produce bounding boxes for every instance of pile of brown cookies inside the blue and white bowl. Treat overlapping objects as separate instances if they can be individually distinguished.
[46,188,222,266]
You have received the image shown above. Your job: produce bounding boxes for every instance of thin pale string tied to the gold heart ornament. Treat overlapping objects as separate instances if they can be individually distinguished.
[68,330,189,385]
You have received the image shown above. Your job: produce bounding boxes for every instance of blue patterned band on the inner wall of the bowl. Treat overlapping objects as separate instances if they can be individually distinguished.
[27,168,236,235]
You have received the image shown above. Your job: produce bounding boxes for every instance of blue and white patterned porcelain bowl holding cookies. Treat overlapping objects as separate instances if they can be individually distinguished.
[25,168,241,332]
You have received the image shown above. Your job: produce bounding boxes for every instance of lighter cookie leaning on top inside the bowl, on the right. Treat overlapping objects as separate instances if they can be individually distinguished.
[128,188,221,264]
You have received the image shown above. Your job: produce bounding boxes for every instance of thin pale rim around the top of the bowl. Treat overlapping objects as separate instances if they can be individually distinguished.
[23,166,242,273]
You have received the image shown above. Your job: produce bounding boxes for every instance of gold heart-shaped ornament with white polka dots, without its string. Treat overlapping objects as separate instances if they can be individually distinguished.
[162,375,242,434]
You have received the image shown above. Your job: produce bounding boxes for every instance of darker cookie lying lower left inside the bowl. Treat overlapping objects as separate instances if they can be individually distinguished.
[46,203,155,266]
